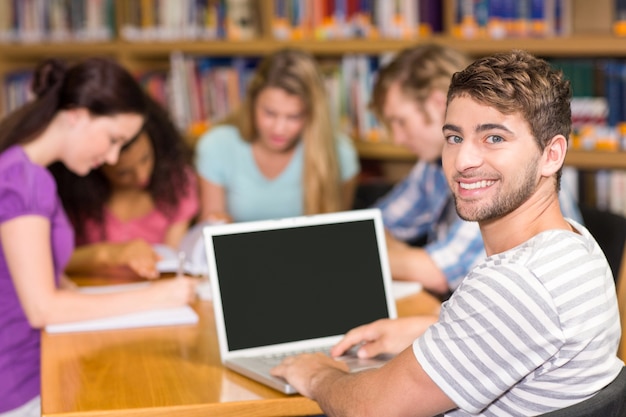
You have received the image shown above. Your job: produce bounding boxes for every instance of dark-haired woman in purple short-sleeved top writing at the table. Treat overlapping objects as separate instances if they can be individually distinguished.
[0,58,195,417]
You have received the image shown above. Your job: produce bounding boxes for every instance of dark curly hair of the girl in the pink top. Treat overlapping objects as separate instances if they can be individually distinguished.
[50,95,193,242]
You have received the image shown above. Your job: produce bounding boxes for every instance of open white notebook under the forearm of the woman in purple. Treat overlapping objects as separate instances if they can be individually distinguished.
[45,282,198,333]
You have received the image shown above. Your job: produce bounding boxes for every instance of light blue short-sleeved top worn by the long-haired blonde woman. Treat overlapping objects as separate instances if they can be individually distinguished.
[196,125,360,222]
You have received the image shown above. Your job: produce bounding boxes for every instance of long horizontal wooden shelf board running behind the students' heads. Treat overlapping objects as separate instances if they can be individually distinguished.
[0,35,626,61]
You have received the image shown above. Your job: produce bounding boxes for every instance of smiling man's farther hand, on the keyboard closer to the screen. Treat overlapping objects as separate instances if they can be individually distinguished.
[330,315,437,358]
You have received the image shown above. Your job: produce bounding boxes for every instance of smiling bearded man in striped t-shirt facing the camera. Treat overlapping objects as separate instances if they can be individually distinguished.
[273,51,623,416]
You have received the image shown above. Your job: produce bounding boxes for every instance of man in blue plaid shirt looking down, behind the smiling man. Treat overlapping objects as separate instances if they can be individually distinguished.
[364,43,581,300]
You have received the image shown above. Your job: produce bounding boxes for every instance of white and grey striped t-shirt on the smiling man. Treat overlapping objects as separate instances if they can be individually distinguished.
[413,222,623,416]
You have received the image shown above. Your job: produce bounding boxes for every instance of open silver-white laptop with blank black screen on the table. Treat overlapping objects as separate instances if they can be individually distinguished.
[203,209,397,394]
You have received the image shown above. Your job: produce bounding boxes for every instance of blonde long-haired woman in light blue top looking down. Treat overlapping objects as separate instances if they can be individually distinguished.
[196,49,360,222]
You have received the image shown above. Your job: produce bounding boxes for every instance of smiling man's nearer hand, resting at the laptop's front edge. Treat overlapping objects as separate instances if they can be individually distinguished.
[270,353,349,398]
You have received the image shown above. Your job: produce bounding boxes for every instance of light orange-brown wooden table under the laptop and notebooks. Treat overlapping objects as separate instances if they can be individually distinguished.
[41,276,439,417]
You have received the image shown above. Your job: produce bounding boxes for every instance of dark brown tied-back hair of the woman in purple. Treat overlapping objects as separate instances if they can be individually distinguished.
[0,57,146,152]
